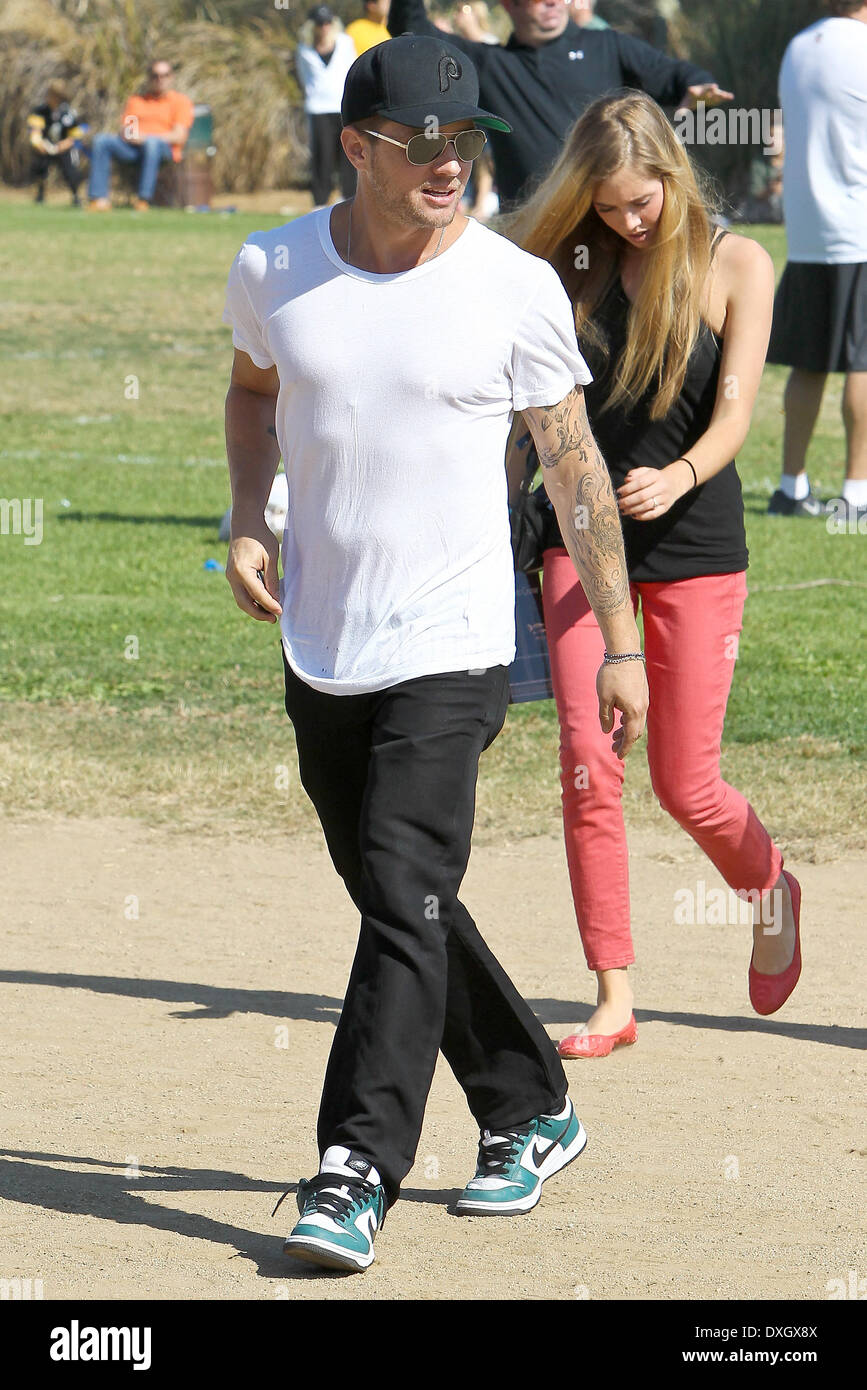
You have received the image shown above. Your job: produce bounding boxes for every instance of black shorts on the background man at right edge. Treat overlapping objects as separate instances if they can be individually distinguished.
[767,261,867,371]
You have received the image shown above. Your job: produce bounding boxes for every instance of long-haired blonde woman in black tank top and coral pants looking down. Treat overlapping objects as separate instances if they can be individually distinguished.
[510,93,800,1056]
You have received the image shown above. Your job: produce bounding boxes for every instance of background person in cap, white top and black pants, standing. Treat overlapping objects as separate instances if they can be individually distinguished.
[295,4,357,207]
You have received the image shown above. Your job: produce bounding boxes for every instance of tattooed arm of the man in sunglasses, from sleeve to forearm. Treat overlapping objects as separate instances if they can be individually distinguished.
[538,388,629,614]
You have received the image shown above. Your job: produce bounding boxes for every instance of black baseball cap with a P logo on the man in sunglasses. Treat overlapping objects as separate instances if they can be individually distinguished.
[340,33,511,133]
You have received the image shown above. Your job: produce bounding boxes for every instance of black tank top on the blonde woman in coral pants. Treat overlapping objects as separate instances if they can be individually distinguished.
[550,265,749,582]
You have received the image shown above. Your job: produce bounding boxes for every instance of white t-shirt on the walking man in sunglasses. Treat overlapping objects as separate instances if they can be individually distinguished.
[224,209,592,695]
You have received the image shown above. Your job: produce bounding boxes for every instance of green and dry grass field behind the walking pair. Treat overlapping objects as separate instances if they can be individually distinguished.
[0,203,867,858]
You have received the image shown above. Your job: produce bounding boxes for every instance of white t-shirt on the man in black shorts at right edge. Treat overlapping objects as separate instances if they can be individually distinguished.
[779,18,867,265]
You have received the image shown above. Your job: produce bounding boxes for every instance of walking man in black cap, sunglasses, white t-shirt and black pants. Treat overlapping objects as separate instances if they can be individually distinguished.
[224,35,646,1270]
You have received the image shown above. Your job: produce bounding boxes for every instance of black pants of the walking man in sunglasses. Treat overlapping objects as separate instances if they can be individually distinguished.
[283,662,567,1204]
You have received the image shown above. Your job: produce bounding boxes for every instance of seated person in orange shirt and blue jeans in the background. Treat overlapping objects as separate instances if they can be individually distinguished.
[88,58,193,213]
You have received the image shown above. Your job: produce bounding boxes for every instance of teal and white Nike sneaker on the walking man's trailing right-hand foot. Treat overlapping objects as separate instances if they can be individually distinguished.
[457,1097,586,1216]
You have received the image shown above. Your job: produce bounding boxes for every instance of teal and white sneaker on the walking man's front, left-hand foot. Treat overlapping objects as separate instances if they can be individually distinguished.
[274,1145,385,1273]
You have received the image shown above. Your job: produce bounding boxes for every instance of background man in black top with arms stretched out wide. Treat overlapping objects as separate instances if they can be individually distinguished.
[388,0,732,207]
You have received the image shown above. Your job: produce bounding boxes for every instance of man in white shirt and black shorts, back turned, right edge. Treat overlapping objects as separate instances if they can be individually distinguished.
[768,0,867,518]
